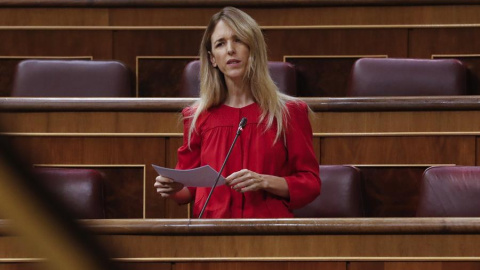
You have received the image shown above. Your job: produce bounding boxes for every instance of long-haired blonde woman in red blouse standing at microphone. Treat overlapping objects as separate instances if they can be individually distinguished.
[155,7,320,218]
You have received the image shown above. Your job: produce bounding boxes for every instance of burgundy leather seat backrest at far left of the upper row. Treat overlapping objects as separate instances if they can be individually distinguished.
[11,60,133,97]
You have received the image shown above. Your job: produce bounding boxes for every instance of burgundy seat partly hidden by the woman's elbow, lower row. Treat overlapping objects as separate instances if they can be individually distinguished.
[293,165,365,218]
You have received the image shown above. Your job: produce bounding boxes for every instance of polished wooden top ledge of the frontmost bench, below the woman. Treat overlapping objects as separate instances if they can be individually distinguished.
[78,218,480,234]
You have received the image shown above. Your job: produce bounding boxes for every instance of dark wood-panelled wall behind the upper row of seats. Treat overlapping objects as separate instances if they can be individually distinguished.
[0,0,480,97]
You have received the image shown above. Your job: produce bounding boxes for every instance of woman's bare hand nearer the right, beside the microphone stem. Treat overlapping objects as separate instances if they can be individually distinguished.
[225,169,267,192]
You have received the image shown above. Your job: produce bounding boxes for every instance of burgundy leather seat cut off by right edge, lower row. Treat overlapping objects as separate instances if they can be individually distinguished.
[416,166,480,217]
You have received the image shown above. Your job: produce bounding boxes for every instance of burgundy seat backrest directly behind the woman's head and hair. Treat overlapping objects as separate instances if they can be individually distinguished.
[179,60,297,97]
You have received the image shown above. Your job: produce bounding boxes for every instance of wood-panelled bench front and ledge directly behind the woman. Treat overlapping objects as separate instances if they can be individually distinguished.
[0,97,480,218]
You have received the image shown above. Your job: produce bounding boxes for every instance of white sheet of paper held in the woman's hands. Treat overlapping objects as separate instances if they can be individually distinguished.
[152,164,225,187]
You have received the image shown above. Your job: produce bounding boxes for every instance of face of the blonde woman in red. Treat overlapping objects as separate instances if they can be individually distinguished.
[210,20,250,81]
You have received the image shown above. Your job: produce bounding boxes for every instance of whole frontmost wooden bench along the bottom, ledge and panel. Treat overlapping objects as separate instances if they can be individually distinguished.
[0,218,480,269]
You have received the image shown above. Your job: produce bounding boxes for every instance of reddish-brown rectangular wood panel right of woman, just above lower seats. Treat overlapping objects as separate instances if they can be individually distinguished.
[320,135,476,165]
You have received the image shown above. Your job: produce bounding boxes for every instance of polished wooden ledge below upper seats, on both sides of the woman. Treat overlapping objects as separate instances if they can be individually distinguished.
[4,96,480,111]
